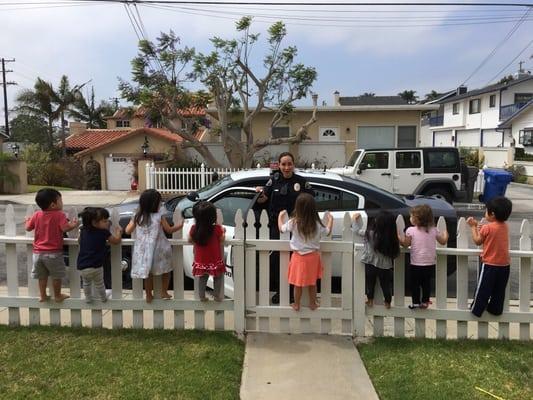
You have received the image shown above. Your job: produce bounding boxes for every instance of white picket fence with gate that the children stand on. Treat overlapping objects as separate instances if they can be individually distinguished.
[0,206,533,340]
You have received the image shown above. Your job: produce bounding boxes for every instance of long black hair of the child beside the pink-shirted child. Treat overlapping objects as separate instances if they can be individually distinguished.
[365,211,400,259]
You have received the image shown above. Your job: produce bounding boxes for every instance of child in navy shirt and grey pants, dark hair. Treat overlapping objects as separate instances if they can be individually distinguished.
[77,207,122,304]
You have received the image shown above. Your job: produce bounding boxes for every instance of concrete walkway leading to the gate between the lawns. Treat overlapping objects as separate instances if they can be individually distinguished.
[240,333,379,400]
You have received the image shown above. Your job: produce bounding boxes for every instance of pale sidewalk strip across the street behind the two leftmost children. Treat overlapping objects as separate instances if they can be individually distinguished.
[0,190,139,207]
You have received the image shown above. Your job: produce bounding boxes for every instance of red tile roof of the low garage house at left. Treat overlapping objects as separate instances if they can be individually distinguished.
[66,128,183,156]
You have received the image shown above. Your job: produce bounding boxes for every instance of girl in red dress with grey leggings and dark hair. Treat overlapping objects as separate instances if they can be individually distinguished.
[189,201,226,301]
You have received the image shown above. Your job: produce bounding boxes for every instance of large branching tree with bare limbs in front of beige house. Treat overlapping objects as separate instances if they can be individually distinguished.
[120,17,316,167]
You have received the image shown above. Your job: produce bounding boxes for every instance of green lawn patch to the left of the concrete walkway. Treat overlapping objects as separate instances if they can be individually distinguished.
[0,326,244,399]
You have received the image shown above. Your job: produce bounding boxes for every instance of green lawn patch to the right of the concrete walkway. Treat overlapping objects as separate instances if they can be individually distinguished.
[358,338,533,400]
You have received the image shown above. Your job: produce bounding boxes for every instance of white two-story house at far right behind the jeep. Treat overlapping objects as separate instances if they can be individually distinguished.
[423,73,533,152]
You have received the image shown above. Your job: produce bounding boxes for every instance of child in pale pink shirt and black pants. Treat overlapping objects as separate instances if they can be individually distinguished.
[399,204,448,309]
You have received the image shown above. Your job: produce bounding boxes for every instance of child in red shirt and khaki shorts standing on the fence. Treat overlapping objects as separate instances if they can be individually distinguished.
[25,188,78,303]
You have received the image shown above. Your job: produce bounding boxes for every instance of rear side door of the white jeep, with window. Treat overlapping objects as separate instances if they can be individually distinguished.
[392,150,424,194]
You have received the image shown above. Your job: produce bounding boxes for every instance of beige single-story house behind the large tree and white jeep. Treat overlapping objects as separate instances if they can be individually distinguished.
[204,92,438,167]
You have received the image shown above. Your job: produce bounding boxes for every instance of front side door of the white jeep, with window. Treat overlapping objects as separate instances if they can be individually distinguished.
[358,151,393,192]
